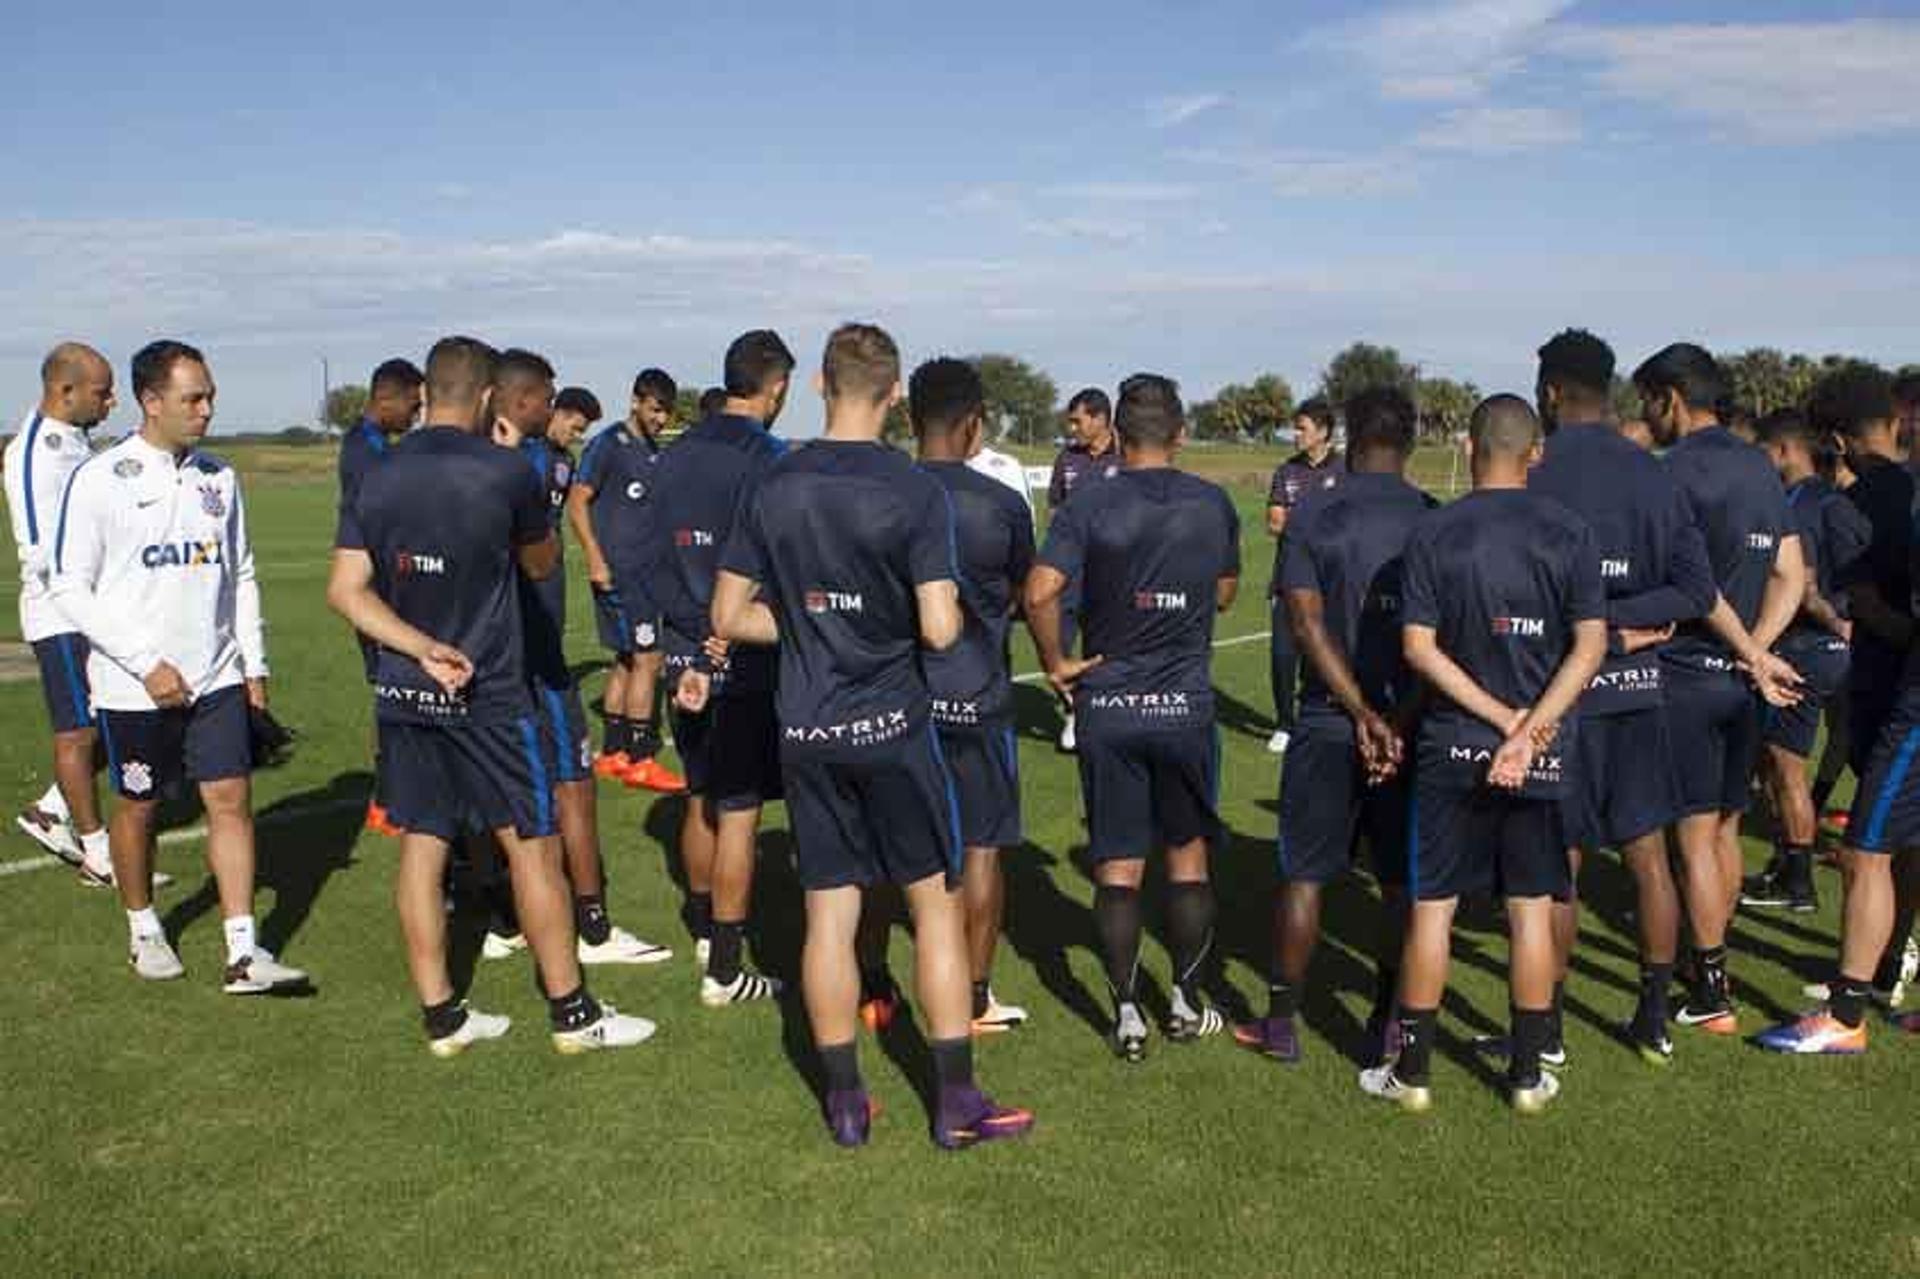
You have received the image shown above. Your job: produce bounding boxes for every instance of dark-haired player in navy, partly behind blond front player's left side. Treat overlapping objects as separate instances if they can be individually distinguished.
[647,328,793,1008]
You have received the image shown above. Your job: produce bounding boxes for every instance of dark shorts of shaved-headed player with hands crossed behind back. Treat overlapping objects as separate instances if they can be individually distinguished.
[1407,774,1572,901]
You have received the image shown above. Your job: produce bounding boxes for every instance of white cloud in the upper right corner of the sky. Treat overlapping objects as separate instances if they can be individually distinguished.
[1553,19,1920,142]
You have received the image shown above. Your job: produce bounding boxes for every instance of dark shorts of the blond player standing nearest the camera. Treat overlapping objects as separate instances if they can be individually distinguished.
[781,724,960,891]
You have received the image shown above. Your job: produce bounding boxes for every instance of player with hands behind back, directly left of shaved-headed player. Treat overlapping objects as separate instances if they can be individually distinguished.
[1233,388,1434,1062]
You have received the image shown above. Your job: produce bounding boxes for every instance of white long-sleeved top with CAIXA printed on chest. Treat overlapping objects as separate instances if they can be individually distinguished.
[52,434,267,711]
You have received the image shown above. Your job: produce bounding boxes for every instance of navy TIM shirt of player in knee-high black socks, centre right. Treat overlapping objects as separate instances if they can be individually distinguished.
[1041,467,1240,734]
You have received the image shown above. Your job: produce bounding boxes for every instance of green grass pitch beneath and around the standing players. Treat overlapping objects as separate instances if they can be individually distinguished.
[0,441,1920,1279]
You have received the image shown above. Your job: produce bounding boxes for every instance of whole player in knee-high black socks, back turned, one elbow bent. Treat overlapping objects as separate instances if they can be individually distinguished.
[1027,373,1240,1062]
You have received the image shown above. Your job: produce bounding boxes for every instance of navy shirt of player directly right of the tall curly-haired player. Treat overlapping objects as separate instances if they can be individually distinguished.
[1661,426,1793,672]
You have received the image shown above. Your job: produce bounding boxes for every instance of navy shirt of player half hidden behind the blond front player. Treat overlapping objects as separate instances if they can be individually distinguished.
[920,461,1033,728]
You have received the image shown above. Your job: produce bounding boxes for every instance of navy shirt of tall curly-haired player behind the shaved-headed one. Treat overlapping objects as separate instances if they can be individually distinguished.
[1526,422,1718,716]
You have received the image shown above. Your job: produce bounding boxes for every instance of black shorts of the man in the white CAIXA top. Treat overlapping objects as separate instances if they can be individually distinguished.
[100,684,253,799]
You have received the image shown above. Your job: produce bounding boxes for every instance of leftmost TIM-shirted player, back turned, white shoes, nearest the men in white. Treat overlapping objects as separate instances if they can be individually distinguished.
[326,338,655,1058]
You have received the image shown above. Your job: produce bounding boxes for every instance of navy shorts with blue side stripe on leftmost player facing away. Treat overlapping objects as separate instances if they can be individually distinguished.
[380,716,559,839]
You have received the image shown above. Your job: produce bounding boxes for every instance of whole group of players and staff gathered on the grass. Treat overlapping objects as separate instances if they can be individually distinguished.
[6,325,1920,1148]
